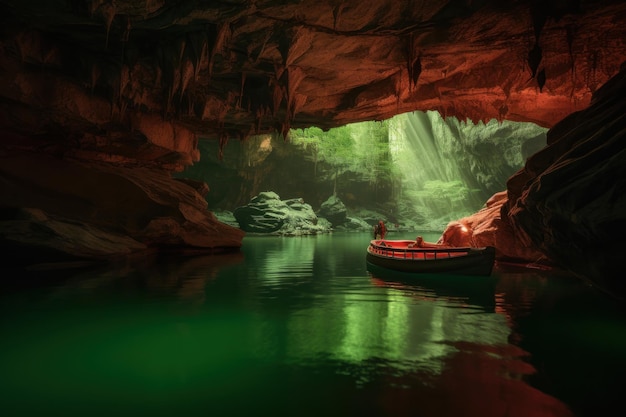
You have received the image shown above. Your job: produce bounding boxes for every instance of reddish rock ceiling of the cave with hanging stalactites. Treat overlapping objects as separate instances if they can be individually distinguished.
[0,0,626,159]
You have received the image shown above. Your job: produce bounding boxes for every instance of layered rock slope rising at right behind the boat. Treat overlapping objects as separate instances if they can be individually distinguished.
[444,64,626,298]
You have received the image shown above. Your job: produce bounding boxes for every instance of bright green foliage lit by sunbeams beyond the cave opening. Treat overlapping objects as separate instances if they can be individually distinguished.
[290,117,480,224]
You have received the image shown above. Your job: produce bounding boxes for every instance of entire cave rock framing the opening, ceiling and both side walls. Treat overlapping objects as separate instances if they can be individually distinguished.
[0,0,626,298]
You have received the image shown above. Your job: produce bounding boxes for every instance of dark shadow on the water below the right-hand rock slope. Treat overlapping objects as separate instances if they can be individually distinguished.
[496,267,626,417]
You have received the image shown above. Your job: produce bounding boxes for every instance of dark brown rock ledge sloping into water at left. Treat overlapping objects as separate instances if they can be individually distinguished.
[0,153,244,263]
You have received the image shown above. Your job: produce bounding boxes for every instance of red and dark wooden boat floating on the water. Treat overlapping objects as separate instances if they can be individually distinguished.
[366,239,496,275]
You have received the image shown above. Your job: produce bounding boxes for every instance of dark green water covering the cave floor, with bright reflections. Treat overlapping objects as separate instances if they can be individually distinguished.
[0,234,626,417]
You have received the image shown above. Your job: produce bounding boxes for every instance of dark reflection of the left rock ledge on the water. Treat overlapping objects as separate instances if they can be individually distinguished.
[1,252,244,306]
